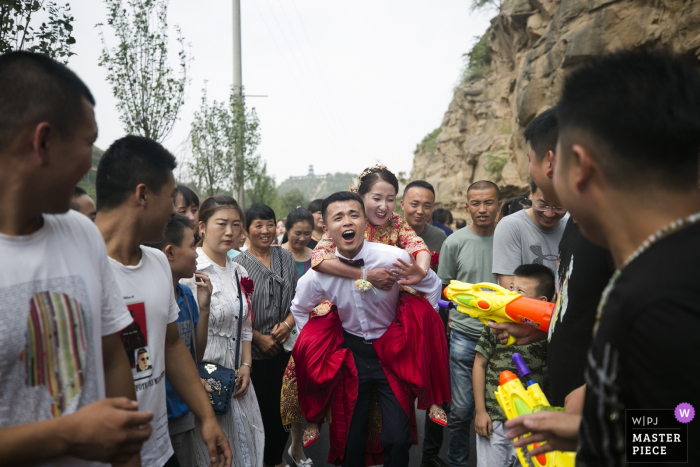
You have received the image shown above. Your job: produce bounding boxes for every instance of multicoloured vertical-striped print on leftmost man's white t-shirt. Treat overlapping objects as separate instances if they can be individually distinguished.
[19,292,87,418]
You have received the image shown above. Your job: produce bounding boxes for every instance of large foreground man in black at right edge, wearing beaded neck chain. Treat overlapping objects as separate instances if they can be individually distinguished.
[506,51,700,466]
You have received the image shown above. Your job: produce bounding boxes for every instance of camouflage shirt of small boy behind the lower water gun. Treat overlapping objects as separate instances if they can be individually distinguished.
[476,326,547,422]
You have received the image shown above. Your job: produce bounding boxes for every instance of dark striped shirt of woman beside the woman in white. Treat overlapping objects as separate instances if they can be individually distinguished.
[233,246,299,360]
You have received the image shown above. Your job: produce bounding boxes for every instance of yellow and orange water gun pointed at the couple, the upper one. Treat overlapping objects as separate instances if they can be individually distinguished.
[438,281,555,345]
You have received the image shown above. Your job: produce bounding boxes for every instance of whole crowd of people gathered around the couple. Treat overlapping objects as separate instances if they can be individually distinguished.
[0,45,700,467]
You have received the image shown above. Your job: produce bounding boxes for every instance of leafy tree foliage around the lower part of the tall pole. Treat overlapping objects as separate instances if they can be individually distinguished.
[190,85,262,202]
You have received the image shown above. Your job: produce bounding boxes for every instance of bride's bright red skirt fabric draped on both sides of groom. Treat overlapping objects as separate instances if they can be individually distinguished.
[292,292,450,466]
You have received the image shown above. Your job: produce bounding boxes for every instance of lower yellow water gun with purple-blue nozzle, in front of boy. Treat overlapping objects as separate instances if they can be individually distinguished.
[495,353,576,467]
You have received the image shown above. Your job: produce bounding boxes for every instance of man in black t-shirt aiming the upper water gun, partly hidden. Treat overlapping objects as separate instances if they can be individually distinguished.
[493,108,615,411]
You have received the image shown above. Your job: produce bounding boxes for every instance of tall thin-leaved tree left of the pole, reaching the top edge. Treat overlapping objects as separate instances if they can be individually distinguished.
[98,0,189,142]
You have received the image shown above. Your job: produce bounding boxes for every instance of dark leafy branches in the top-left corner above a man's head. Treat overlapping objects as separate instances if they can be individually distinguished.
[0,0,75,63]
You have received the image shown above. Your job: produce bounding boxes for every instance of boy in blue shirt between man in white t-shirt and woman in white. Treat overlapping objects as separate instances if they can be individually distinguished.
[149,217,213,467]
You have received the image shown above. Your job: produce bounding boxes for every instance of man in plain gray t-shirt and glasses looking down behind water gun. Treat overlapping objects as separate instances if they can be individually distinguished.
[492,184,568,288]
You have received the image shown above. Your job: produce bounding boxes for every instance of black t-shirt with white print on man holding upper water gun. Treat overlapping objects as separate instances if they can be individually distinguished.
[547,218,615,407]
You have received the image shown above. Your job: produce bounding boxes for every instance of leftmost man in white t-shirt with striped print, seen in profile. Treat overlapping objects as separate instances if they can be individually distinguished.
[0,52,153,467]
